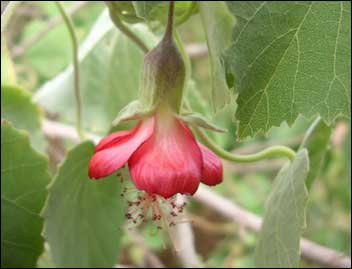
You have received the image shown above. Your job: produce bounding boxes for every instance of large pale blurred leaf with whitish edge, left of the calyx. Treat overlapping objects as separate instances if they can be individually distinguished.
[35,11,156,134]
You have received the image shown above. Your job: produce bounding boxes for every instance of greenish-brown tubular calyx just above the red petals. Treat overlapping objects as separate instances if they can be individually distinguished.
[140,30,186,113]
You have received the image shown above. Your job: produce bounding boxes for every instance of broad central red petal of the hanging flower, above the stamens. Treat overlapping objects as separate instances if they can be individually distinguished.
[128,117,202,198]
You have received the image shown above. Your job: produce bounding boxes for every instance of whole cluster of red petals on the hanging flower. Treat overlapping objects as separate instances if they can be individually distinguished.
[89,106,222,198]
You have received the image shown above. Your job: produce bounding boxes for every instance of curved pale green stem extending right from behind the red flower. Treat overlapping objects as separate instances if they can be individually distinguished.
[194,127,296,163]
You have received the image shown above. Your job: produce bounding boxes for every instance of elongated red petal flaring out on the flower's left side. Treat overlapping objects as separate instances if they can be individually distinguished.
[88,118,154,178]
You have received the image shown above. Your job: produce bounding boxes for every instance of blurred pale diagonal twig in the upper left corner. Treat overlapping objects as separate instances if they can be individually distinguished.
[11,1,90,58]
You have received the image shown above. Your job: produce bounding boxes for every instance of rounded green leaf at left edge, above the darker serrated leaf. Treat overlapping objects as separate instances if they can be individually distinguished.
[1,85,44,152]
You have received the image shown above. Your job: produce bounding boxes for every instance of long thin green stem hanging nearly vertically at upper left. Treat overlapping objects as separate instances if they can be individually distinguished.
[55,1,84,140]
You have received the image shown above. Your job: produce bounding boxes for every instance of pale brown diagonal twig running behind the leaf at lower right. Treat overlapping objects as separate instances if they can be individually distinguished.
[194,187,351,268]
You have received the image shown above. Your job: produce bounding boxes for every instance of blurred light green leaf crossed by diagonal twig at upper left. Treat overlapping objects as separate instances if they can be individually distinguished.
[21,1,104,80]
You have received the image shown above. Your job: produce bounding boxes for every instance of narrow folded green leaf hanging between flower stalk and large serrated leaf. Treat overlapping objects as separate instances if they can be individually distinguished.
[198,1,235,111]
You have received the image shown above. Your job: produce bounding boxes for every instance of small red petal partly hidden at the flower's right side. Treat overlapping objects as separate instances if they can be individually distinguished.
[198,143,222,186]
